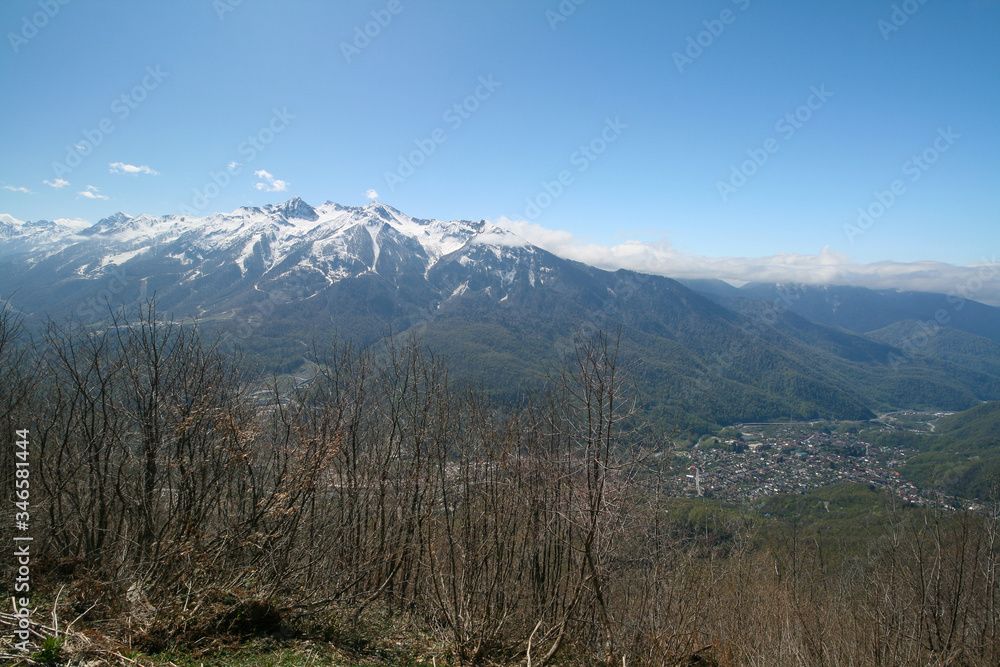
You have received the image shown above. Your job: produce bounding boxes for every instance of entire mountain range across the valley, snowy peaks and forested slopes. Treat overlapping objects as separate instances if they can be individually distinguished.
[0,198,1000,428]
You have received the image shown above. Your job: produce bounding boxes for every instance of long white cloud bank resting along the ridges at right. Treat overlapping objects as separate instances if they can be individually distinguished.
[497,218,1000,306]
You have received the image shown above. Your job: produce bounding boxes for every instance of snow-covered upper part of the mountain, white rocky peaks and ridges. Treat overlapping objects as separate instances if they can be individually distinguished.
[0,197,537,289]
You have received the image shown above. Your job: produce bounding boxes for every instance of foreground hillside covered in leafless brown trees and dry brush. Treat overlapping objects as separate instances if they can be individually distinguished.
[0,305,1000,667]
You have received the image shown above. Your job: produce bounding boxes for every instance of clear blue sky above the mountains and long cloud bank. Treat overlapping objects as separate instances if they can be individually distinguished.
[0,0,1000,290]
